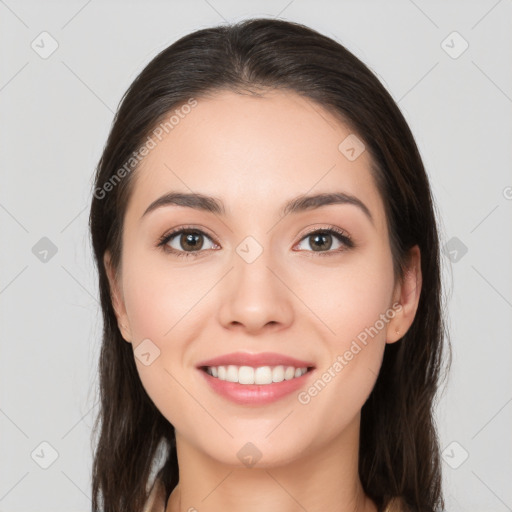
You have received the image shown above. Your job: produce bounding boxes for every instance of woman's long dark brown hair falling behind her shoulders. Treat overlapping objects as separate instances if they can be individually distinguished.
[89,18,451,512]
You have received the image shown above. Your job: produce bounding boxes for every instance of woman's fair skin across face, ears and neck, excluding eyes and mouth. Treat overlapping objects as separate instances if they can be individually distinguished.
[105,91,421,512]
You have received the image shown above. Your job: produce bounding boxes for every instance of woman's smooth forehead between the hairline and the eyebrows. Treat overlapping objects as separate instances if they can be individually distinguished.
[129,90,382,225]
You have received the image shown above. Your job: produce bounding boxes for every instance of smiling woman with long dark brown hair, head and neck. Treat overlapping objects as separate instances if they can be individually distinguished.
[90,19,445,512]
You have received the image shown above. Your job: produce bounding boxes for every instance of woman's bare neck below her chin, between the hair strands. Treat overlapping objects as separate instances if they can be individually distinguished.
[166,418,377,512]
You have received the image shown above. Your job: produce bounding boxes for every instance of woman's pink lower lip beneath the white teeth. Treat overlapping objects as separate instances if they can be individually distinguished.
[199,369,314,405]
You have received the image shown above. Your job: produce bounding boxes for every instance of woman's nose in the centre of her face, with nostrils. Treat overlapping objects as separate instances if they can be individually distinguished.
[218,246,294,334]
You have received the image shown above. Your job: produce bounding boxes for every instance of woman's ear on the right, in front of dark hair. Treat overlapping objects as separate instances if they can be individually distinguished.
[386,245,422,343]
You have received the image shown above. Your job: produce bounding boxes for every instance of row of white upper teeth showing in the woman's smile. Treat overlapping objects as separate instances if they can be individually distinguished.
[206,364,308,384]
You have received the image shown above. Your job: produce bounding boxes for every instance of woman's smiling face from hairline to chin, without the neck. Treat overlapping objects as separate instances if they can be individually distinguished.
[105,92,420,466]
